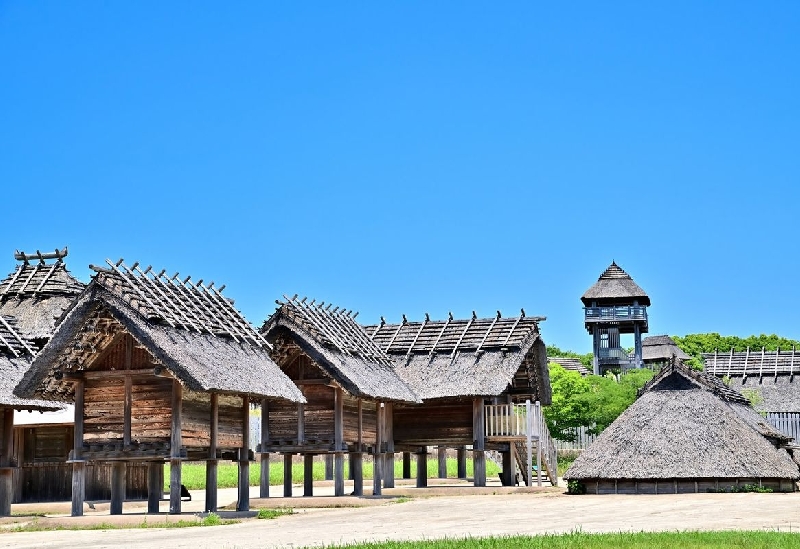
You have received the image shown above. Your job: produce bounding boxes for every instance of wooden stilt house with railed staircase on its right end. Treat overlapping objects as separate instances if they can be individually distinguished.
[366,311,557,486]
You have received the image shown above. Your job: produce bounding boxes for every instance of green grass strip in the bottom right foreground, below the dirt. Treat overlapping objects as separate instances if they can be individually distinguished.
[300,531,800,549]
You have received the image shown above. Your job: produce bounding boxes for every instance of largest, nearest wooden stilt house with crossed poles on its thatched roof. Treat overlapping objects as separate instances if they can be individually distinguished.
[16,260,305,516]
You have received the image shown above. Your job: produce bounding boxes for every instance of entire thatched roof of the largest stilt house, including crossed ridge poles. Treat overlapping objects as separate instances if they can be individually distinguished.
[17,260,305,402]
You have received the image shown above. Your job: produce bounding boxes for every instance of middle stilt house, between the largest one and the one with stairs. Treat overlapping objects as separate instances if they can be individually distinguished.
[260,296,418,497]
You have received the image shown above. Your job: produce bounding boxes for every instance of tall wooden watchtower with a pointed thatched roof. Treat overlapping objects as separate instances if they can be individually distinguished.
[581,261,650,375]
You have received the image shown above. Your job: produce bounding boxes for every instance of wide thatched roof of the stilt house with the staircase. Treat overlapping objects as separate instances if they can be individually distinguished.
[366,312,551,405]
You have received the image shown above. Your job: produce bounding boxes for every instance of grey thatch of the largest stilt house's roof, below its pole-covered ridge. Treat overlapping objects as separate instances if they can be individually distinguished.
[17,272,305,402]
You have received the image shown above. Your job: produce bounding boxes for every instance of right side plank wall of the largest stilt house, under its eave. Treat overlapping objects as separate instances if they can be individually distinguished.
[181,390,242,450]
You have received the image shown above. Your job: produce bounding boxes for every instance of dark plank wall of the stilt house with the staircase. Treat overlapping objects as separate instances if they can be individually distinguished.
[394,400,473,445]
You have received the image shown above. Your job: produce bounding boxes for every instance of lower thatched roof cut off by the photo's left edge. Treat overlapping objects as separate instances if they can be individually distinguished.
[0,316,60,411]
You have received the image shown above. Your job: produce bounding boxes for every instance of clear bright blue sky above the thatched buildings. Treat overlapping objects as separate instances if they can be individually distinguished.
[0,0,800,352]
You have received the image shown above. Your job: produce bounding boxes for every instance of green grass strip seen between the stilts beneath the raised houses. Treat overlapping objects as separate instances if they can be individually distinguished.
[169,459,500,490]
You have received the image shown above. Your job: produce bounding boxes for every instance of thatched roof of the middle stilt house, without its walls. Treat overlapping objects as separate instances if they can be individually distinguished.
[261,296,419,402]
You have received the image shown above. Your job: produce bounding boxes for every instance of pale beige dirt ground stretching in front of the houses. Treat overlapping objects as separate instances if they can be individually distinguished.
[0,482,800,549]
